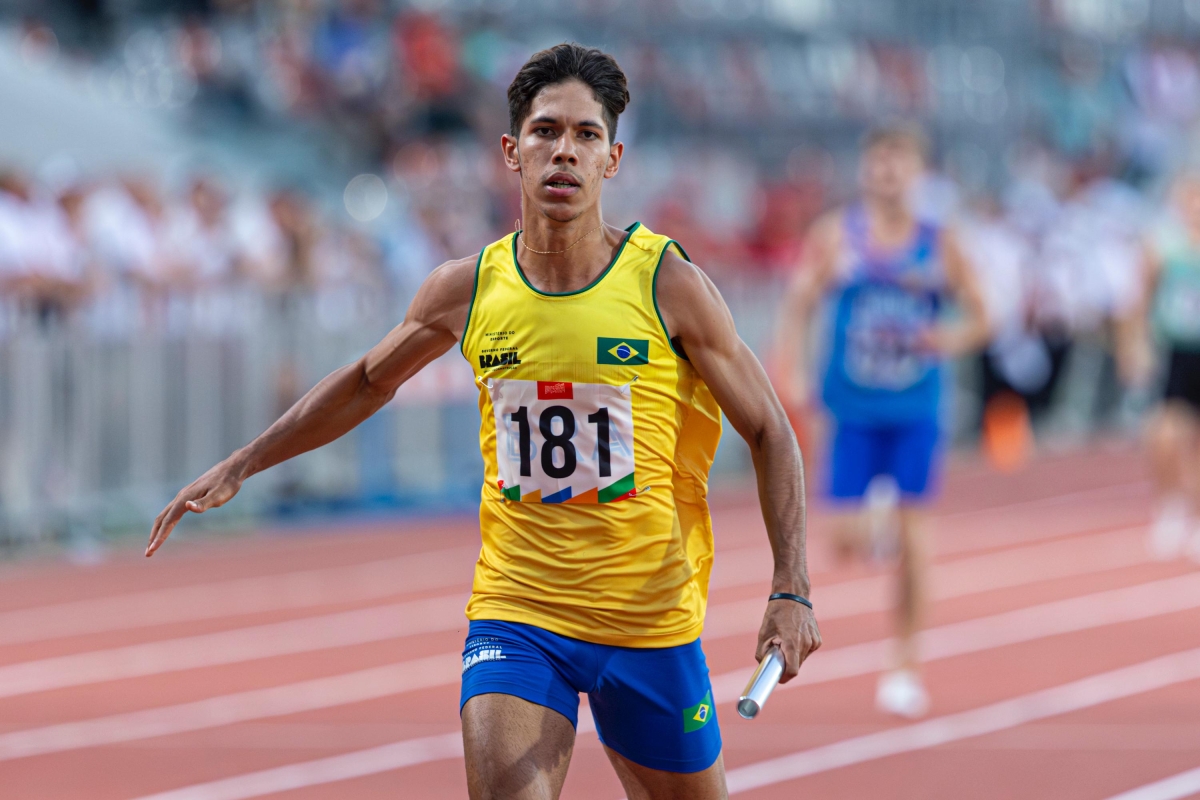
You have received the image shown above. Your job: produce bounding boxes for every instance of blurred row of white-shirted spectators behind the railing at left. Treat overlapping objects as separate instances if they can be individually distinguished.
[0,162,398,335]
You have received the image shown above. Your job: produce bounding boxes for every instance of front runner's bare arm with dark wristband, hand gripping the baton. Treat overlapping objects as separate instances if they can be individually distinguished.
[656,253,821,681]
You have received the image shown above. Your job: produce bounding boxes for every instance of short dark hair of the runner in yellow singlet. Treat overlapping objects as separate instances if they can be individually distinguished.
[509,42,629,142]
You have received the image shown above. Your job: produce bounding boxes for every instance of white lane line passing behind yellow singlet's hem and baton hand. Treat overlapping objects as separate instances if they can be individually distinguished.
[0,529,1147,698]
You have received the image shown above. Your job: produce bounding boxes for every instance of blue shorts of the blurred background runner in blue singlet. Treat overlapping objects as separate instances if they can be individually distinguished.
[829,420,941,501]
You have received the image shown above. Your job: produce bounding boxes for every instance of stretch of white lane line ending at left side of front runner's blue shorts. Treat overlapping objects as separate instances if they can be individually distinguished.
[0,652,462,760]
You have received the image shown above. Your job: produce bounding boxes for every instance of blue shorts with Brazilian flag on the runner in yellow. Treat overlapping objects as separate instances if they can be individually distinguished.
[458,620,721,772]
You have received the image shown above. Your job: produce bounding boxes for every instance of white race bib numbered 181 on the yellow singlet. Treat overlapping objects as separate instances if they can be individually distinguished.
[487,378,637,504]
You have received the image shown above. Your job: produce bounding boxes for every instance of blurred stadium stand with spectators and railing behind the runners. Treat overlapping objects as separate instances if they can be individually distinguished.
[0,0,1200,541]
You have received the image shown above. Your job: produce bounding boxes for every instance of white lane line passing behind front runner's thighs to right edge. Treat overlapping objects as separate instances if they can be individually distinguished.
[124,649,1200,800]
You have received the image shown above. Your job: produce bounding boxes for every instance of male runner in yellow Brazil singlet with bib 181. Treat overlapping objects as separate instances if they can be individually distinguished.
[146,44,821,800]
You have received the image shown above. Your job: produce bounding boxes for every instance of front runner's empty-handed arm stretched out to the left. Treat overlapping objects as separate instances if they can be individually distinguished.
[146,258,475,557]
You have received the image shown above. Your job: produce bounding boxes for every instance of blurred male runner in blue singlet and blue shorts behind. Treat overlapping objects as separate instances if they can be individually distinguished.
[776,127,988,717]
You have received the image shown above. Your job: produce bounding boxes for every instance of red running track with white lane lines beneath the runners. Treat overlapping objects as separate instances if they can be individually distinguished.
[0,450,1200,800]
